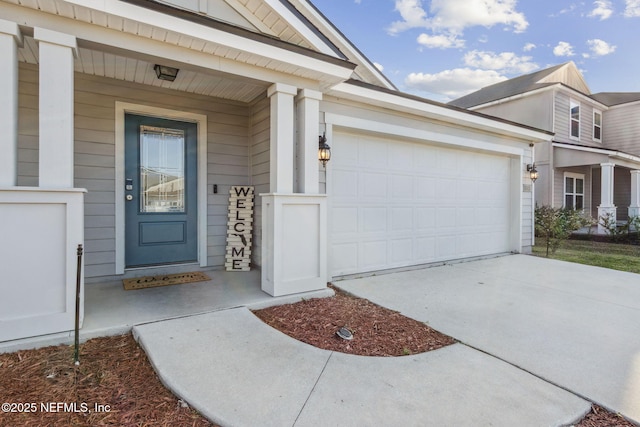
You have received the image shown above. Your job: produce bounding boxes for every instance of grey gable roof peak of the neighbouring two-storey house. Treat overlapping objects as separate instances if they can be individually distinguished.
[449,62,591,108]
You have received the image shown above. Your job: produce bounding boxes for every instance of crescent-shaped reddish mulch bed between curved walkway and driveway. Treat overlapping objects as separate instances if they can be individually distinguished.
[254,290,455,356]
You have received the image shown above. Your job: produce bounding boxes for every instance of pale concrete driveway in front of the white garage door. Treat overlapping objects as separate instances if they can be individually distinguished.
[336,255,640,423]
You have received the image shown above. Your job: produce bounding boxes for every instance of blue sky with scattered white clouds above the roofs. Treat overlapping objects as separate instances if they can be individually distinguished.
[311,0,640,102]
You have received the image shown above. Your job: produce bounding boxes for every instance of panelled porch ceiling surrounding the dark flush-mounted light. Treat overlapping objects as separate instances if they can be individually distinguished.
[18,36,269,103]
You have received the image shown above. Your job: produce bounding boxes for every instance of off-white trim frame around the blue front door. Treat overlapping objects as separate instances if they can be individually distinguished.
[115,101,207,274]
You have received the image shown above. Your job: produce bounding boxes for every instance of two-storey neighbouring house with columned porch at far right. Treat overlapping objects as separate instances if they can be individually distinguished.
[449,62,640,233]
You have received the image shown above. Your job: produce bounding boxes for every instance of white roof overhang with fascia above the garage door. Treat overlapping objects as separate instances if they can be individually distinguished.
[328,80,553,143]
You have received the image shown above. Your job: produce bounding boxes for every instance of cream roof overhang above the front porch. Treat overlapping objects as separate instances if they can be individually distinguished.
[8,0,356,89]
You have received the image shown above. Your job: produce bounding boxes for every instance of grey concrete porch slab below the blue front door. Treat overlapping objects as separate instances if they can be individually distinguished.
[0,270,333,353]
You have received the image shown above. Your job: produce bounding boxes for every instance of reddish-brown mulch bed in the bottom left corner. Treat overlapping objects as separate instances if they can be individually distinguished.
[0,334,213,427]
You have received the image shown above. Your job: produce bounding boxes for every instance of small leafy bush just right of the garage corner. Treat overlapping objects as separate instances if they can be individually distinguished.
[535,206,592,257]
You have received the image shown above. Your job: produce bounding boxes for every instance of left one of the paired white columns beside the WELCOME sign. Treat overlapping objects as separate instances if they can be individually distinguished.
[267,83,297,194]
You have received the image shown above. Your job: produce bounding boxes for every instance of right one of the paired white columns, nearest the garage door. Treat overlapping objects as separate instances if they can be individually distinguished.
[296,89,322,194]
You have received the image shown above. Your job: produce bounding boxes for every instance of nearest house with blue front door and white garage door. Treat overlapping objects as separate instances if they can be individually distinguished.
[0,0,551,341]
